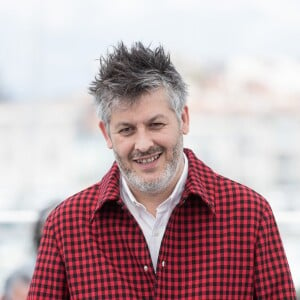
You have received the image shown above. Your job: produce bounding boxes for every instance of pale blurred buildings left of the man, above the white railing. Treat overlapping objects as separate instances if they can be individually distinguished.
[0,99,109,209]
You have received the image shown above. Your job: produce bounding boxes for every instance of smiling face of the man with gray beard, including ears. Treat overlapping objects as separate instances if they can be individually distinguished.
[100,88,189,194]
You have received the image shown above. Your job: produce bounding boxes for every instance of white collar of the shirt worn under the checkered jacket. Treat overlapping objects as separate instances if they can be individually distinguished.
[120,153,188,212]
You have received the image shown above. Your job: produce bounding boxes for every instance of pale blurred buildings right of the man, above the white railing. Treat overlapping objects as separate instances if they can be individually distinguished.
[187,58,300,210]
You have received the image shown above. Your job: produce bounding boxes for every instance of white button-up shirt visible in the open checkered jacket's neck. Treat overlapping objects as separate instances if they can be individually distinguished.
[120,153,188,270]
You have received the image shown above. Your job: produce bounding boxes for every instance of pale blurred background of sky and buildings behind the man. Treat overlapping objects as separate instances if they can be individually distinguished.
[0,0,300,294]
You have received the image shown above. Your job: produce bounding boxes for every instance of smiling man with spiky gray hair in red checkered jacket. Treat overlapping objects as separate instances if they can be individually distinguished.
[28,43,295,300]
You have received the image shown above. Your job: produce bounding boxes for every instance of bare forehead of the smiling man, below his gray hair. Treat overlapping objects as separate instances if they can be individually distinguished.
[111,89,175,123]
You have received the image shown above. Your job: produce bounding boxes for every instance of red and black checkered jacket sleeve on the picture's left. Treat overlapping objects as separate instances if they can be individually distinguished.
[27,214,70,300]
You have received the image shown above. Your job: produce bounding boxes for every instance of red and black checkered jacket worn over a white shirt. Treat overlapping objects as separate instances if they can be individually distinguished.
[28,150,296,300]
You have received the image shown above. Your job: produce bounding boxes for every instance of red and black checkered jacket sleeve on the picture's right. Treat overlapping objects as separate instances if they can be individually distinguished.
[254,204,296,300]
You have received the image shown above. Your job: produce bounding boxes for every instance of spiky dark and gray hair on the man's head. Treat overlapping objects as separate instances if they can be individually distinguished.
[89,42,187,125]
